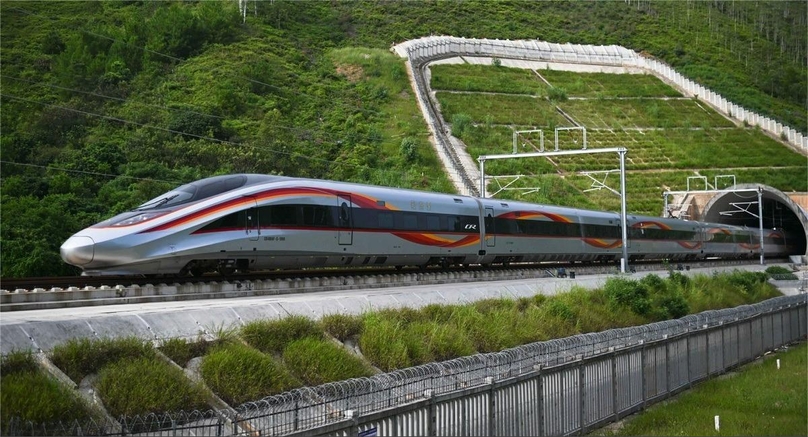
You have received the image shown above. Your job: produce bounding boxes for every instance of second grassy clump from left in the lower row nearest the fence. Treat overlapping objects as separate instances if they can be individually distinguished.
[96,357,206,417]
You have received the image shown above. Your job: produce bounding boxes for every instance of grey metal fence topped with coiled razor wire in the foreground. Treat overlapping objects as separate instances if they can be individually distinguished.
[3,294,808,436]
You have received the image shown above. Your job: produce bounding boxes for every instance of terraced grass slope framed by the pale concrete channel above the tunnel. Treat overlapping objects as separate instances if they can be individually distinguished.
[431,64,808,215]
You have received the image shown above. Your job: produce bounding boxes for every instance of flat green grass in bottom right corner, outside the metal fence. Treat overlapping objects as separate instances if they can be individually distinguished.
[594,343,808,436]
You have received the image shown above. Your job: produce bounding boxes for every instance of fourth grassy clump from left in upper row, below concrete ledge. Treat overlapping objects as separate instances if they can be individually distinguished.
[241,315,323,354]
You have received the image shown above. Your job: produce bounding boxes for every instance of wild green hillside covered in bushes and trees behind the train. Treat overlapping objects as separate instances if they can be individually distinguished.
[0,0,808,277]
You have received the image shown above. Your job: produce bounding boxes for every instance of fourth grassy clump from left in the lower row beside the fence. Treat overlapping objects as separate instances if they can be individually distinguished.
[283,337,372,386]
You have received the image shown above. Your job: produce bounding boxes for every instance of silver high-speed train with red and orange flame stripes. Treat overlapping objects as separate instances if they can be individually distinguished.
[61,174,792,276]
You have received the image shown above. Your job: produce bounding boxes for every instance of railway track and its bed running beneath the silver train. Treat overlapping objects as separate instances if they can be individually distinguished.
[0,260,785,312]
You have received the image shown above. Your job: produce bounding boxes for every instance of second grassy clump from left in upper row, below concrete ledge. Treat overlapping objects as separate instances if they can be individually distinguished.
[51,337,154,384]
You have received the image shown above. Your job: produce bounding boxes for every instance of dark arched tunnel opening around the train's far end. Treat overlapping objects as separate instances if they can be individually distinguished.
[700,184,808,256]
